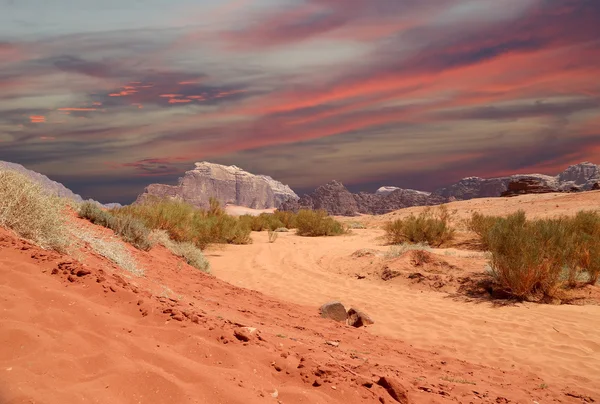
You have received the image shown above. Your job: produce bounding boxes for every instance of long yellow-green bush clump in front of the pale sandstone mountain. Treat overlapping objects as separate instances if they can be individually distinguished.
[111,199,252,249]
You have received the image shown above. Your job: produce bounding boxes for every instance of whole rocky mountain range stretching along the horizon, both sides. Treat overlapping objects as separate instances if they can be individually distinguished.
[0,161,600,215]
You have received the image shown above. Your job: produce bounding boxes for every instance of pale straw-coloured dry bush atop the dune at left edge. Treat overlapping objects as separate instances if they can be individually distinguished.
[0,170,67,251]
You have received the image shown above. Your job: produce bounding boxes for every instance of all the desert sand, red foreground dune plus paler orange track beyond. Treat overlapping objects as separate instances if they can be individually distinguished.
[0,192,600,404]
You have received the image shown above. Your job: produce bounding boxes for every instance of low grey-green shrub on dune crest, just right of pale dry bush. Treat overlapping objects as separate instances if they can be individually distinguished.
[78,202,152,251]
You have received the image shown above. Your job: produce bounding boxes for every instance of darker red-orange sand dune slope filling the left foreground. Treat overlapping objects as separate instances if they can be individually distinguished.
[0,211,600,404]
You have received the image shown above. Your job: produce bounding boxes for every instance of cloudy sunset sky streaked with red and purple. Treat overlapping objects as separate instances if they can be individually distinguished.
[0,0,600,203]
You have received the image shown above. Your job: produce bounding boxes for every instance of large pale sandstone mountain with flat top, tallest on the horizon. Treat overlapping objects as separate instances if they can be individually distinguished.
[136,162,298,209]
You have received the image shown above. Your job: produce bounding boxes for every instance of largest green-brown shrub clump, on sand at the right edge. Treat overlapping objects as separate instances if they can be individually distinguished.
[469,211,600,298]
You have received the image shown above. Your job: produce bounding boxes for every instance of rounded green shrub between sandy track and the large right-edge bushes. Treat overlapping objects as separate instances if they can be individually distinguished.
[384,206,455,247]
